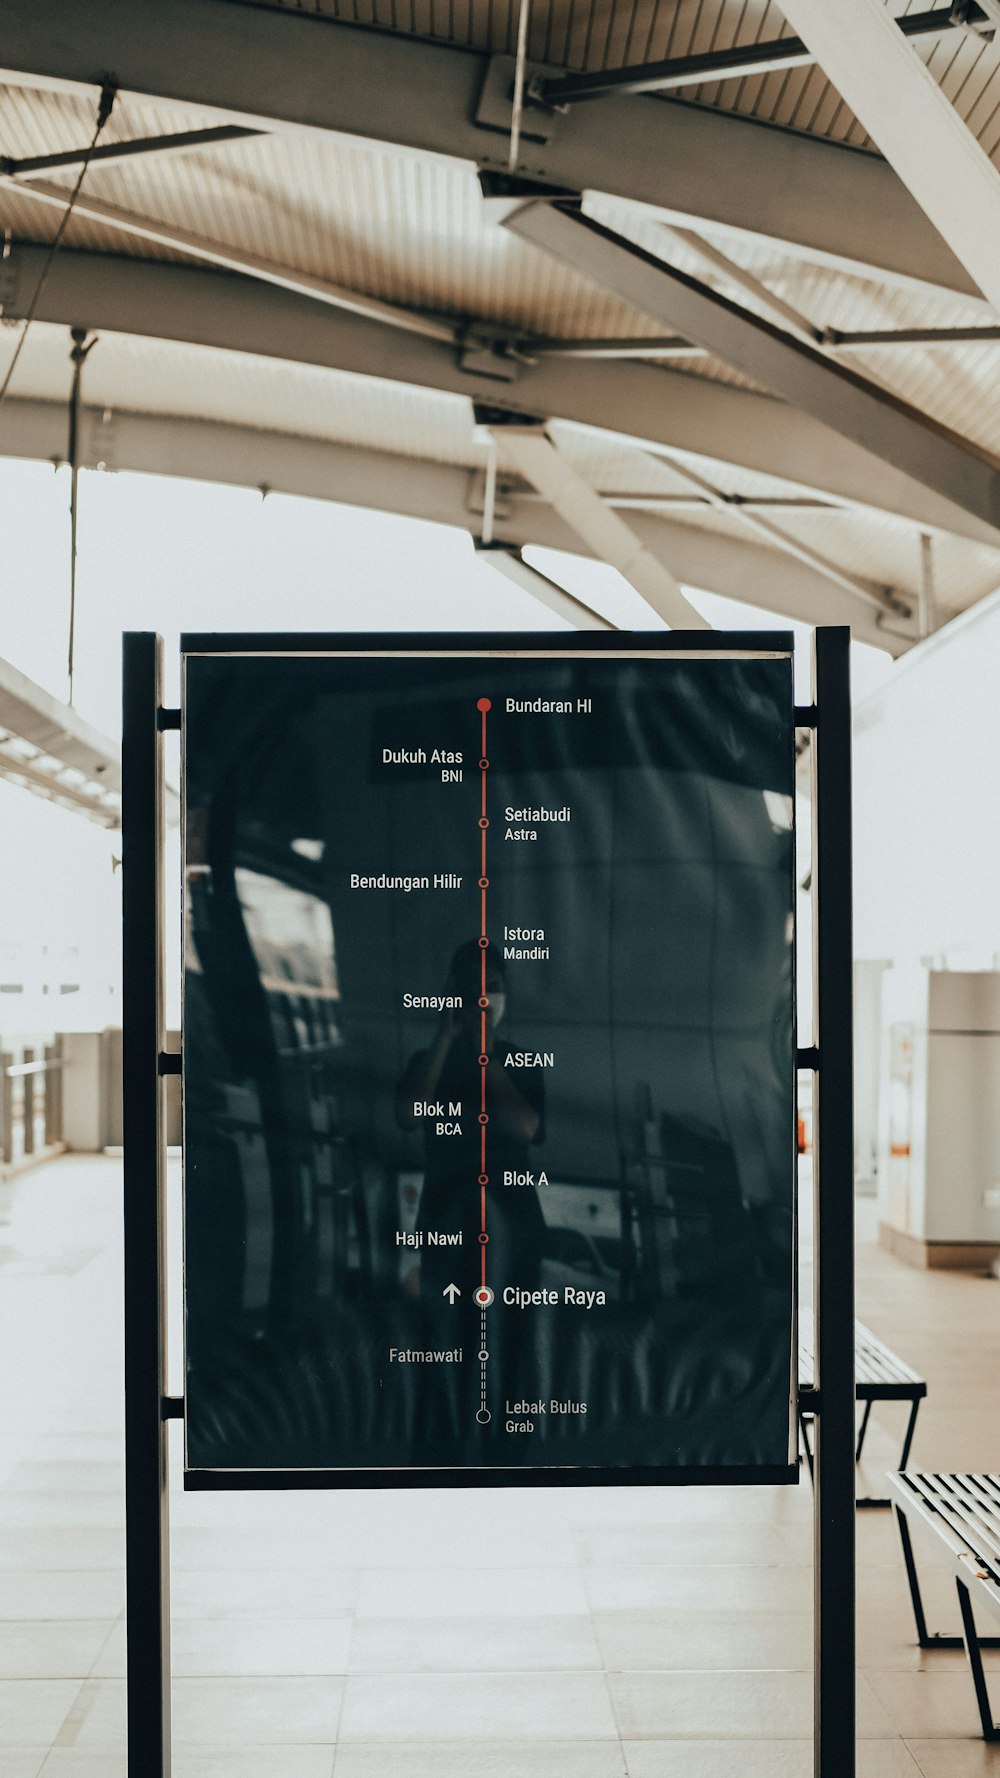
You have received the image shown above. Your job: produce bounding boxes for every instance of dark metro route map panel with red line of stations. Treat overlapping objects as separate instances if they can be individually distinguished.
[183,631,795,1486]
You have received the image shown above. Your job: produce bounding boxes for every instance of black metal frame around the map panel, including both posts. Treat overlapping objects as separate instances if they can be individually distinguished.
[123,628,854,1778]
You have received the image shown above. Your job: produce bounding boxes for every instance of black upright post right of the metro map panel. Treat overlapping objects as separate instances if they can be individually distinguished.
[813,628,856,1778]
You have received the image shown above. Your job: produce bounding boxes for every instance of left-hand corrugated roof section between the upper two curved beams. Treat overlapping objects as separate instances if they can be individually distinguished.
[0,89,669,336]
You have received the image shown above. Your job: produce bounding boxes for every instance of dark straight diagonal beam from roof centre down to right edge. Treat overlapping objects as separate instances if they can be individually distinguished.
[504,198,1000,542]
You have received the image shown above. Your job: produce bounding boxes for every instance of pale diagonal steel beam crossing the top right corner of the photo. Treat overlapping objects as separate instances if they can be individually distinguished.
[781,0,1000,315]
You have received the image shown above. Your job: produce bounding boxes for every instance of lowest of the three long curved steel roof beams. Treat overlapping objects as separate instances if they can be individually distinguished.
[0,396,916,654]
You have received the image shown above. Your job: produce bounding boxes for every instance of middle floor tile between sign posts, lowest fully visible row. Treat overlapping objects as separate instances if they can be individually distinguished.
[340,1673,616,1742]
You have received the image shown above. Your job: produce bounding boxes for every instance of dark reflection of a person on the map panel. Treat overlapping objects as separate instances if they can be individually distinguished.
[395,939,544,1305]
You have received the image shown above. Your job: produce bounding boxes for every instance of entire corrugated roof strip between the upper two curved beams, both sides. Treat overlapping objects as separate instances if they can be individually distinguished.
[0,89,1000,430]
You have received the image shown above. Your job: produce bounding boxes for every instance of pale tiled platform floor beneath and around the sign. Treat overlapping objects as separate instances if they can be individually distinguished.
[0,1157,1000,1778]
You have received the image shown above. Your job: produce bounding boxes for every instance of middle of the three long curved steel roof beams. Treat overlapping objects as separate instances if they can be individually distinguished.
[0,244,998,548]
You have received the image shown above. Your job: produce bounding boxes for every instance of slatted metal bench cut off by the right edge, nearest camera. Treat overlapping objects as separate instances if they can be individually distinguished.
[890,1472,1000,1741]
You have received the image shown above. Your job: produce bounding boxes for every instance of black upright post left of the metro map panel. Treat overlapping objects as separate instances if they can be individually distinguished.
[121,631,171,1778]
